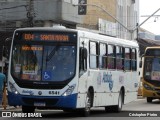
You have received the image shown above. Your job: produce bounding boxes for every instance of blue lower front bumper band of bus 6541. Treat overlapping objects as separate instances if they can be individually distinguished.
[8,92,77,109]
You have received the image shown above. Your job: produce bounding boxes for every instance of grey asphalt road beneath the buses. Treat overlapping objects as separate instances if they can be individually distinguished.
[2,99,160,120]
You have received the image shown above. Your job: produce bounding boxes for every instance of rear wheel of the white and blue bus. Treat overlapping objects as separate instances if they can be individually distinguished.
[115,91,123,112]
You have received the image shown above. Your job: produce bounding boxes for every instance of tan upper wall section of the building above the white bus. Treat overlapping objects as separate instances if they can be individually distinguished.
[79,0,116,29]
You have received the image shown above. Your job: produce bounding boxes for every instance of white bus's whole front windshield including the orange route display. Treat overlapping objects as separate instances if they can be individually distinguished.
[11,30,77,85]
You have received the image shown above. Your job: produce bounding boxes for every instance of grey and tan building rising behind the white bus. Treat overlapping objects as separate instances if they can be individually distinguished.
[0,0,139,70]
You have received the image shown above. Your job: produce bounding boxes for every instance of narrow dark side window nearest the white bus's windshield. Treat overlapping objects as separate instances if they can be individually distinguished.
[79,47,87,76]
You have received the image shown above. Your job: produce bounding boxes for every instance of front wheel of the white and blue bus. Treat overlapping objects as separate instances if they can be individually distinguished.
[82,92,92,117]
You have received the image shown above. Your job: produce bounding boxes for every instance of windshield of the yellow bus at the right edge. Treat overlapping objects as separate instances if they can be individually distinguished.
[144,57,160,81]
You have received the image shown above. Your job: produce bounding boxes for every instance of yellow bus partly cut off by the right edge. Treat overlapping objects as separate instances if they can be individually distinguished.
[140,46,160,103]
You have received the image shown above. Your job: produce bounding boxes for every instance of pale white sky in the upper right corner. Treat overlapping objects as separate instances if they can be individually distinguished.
[139,0,160,35]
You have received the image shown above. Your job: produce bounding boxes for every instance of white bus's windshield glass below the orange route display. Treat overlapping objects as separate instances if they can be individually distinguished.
[11,44,76,82]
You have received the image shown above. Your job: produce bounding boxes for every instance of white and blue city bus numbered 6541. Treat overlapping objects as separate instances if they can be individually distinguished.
[8,27,139,116]
